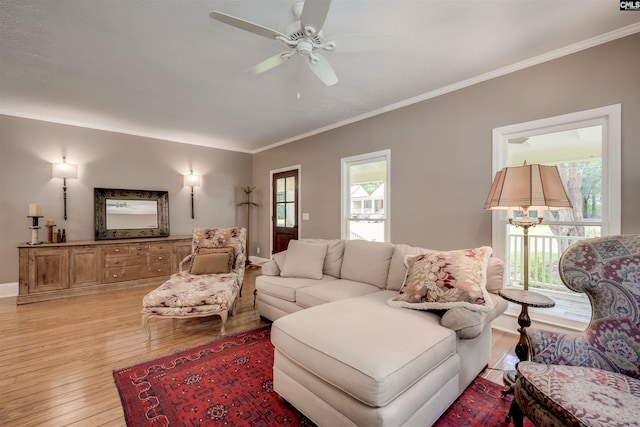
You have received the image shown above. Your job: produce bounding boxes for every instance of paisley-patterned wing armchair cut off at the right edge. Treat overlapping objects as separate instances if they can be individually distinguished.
[510,235,640,427]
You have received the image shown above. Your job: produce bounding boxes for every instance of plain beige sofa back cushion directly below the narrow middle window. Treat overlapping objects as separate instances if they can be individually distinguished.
[340,240,394,289]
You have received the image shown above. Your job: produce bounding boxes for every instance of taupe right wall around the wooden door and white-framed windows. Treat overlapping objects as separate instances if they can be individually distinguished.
[253,34,640,256]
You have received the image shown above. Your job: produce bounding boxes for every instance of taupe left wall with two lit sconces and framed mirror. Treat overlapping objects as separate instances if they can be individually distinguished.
[0,115,252,284]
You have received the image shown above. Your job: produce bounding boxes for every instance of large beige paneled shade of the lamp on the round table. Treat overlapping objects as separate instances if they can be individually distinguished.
[484,163,571,210]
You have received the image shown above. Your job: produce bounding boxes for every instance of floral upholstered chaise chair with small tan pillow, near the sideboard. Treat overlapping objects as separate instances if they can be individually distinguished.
[142,228,246,338]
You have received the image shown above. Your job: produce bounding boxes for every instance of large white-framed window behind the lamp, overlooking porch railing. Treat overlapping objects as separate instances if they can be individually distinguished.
[493,105,620,322]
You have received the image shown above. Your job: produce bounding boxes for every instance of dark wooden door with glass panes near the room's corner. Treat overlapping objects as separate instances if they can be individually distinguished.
[271,169,298,254]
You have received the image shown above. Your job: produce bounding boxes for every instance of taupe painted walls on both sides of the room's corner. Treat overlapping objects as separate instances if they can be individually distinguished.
[0,34,640,284]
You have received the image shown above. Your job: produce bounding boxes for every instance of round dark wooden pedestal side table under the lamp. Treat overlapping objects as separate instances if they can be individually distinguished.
[499,288,556,393]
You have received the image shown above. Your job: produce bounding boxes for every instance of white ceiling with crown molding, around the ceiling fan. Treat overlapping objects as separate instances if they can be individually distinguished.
[0,0,640,152]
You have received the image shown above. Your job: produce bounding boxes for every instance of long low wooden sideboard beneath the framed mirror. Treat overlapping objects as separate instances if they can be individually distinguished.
[17,236,191,304]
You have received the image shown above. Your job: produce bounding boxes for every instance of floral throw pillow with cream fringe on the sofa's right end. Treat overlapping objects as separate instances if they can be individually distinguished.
[387,246,493,311]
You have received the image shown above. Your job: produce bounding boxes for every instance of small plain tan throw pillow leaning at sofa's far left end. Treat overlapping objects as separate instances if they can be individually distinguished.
[280,240,327,279]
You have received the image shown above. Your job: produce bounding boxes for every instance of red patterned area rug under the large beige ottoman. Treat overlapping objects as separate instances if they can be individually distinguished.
[113,326,530,427]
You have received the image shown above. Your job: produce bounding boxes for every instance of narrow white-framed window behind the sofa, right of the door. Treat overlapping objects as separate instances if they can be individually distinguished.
[342,150,391,242]
